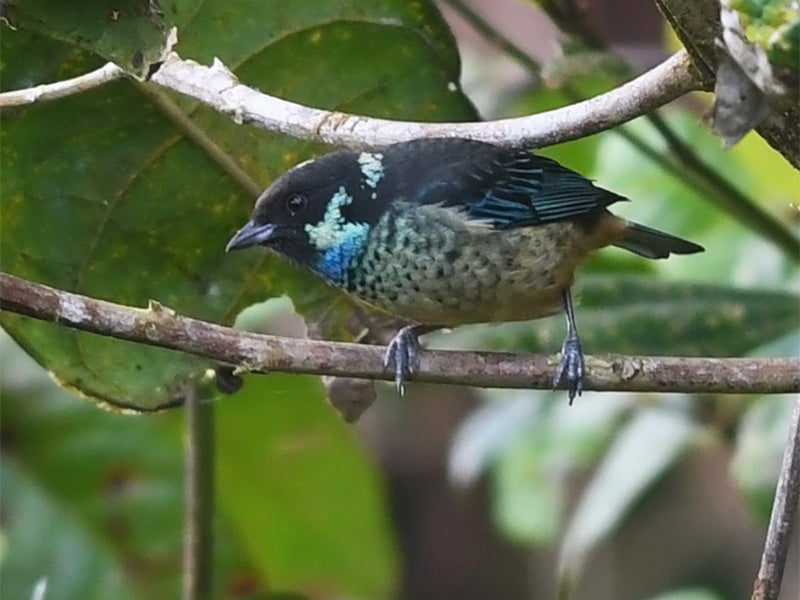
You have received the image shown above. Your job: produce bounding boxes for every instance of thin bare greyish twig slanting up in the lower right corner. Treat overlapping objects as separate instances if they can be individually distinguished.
[751,398,800,600]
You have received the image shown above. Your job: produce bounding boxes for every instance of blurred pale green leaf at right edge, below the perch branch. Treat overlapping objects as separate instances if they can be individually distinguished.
[730,395,794,523]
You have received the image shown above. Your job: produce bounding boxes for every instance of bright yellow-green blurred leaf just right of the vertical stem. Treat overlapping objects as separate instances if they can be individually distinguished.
[217,374,398,598]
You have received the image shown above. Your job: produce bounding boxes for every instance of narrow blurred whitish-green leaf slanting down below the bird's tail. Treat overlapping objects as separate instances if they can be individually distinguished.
[559,406,697,589]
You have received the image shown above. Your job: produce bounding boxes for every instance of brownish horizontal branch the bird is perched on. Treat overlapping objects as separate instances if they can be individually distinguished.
[0,273,800,393]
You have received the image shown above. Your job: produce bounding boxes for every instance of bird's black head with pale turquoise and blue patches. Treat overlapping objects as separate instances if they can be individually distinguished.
[226,150,390,283]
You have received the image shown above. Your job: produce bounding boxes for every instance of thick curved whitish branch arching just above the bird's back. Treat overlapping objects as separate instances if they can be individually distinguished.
[147,52,701,147]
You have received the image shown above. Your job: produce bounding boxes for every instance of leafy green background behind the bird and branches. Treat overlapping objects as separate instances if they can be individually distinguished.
[0,0,800,600]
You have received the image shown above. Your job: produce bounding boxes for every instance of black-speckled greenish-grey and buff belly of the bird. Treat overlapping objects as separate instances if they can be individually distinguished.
[350,216,583,326]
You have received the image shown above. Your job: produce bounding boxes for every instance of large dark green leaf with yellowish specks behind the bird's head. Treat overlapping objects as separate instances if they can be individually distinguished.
[0,0,475,410]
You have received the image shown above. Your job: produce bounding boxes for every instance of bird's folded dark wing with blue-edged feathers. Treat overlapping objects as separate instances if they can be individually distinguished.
[416,151,624,229]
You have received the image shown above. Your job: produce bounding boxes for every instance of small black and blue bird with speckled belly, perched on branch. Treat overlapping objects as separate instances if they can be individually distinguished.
[226,137,703,404]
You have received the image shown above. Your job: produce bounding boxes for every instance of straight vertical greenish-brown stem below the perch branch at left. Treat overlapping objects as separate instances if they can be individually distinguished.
[182,386,214,600]
